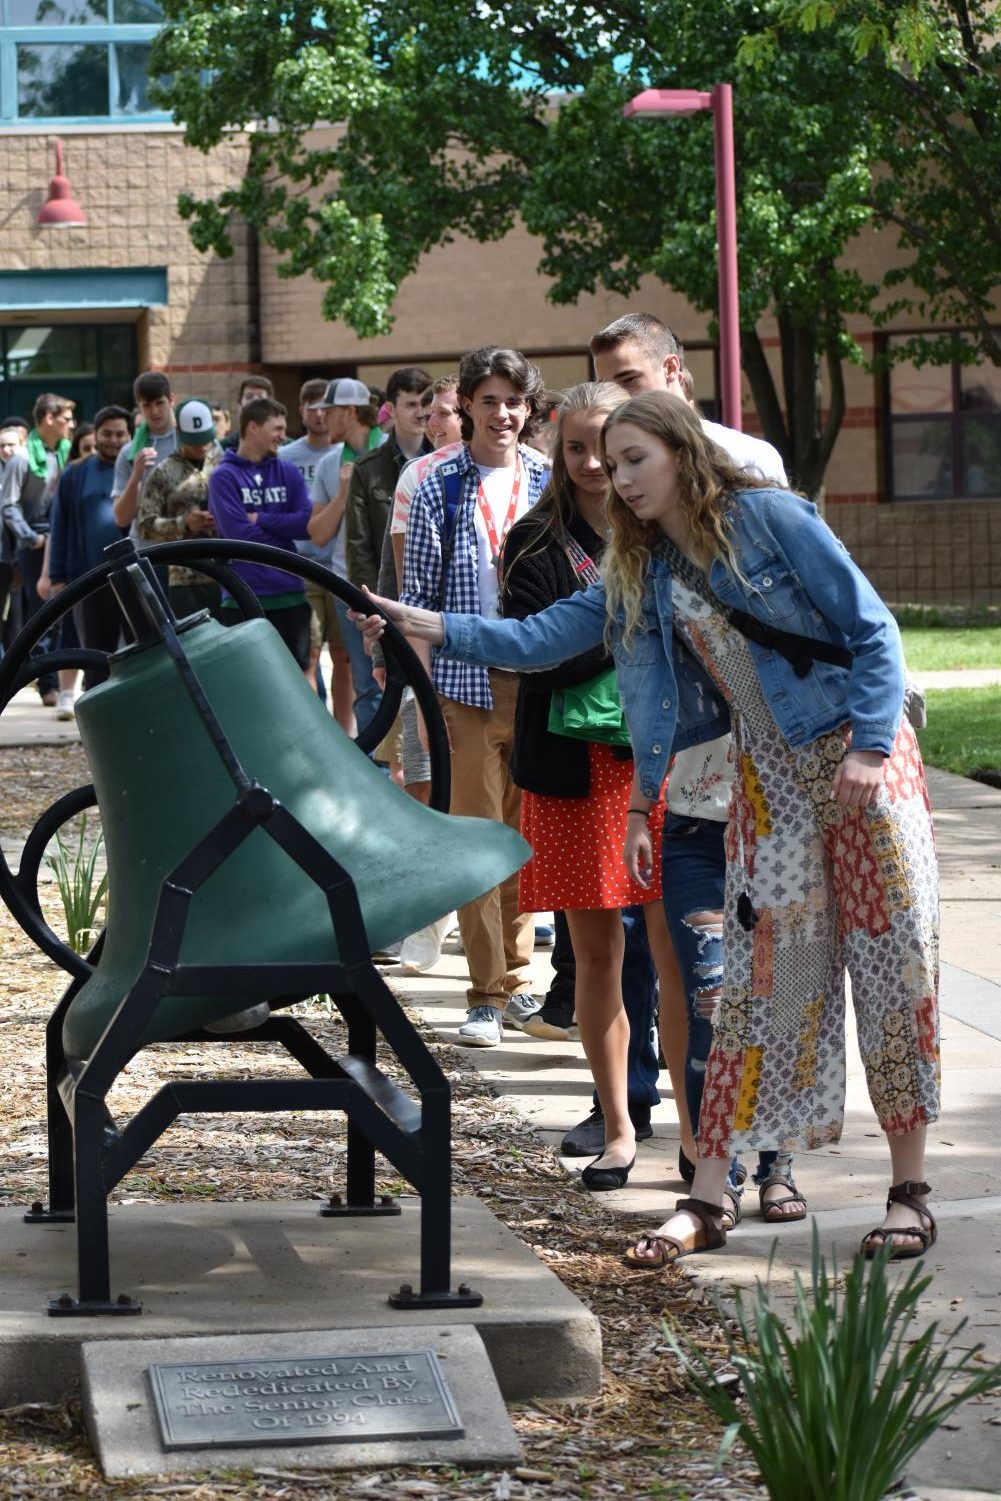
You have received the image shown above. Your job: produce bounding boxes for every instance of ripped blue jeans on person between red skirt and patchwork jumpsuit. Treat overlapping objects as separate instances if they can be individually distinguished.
[662,814,792,1192]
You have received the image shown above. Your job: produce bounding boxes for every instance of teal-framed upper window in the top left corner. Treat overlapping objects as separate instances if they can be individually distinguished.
[0,0,168,123]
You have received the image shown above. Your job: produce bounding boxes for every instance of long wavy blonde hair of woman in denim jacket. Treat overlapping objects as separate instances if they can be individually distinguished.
[602,390,762,644]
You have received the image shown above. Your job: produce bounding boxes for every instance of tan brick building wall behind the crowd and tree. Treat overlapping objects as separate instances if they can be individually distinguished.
[0,128,1001,603]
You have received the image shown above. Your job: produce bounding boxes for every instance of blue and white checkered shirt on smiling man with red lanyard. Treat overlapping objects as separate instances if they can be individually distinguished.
[399,444,549,708]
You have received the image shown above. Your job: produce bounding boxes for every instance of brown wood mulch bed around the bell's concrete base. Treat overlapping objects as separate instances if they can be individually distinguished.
[0,746,764,1501]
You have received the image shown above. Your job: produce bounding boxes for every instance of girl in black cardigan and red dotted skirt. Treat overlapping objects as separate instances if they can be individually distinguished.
[501,383,693,1189]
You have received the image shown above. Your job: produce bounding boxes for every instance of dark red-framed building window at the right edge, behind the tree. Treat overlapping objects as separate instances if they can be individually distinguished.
[887,335,1001,500]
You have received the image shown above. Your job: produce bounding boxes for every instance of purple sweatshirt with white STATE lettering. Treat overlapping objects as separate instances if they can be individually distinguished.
[209,450,312,600]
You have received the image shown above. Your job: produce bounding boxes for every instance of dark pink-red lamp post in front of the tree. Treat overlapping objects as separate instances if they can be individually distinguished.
[623,84,741,431]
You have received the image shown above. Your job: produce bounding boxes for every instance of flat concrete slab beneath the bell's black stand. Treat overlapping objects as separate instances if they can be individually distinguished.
[0,1198,602,1406]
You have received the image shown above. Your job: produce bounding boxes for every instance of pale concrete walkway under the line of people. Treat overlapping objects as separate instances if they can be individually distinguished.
[0,674,1001,1501]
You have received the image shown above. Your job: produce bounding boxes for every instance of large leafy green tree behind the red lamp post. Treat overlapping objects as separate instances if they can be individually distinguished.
[153,0,1001,492]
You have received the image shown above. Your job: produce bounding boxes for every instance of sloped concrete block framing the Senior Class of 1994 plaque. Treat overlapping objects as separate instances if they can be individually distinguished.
[81,1324,521,1480]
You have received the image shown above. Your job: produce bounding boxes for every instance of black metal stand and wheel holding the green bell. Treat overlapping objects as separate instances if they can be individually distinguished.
[0,537,471,1318]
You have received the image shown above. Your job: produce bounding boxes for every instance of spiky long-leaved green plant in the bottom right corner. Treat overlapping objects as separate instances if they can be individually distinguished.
[665,1228,1001,1501]
